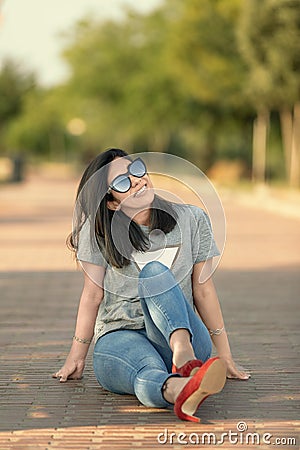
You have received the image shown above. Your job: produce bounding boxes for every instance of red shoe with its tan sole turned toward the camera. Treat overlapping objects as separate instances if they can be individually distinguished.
[174,357,226,422]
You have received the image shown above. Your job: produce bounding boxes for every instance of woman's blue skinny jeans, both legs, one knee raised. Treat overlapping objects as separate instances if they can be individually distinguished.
[93,261,212,408]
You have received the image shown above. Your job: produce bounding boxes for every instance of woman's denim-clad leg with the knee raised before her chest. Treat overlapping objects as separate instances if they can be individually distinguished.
[139,261,212,371]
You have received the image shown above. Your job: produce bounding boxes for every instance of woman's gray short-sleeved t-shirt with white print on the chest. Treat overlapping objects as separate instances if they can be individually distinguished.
[77,204,220,342]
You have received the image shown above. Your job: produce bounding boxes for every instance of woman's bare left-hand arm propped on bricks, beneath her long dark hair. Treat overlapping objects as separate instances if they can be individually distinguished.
[52,266,105,382]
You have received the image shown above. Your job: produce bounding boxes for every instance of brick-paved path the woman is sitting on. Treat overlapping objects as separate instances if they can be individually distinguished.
[0,175,300,450]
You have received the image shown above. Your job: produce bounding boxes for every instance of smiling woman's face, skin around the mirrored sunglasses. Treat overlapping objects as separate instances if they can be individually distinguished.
[107,158,154,218]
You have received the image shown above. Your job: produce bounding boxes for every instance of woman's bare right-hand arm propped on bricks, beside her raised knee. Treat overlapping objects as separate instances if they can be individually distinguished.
[192,261,249,380]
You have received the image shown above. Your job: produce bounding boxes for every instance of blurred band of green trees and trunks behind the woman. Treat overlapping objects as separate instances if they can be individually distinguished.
[0,0,300,186]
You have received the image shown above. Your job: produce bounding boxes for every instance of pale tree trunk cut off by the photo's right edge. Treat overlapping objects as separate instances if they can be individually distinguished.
[290,102,300,187]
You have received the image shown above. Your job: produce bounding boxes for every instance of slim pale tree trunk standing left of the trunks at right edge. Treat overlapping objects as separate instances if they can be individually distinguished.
[252,109,270,183]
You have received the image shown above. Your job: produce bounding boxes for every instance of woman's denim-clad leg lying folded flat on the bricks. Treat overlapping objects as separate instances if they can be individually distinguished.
[93,330,176,408]
